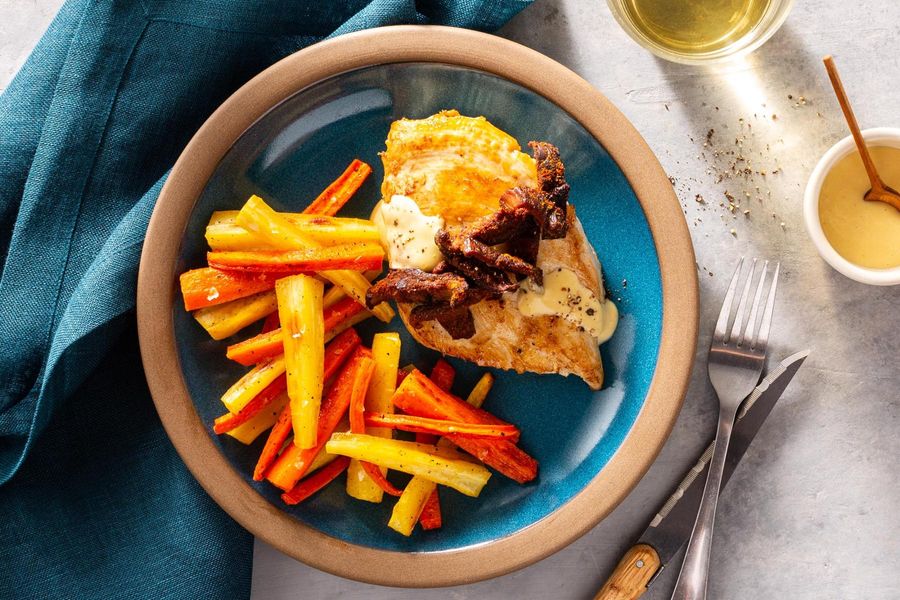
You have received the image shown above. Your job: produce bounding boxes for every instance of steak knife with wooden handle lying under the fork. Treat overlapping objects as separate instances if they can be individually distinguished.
[594,350,809,600]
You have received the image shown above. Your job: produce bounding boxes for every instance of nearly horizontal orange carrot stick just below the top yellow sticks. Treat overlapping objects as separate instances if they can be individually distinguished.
[206,243,384,274]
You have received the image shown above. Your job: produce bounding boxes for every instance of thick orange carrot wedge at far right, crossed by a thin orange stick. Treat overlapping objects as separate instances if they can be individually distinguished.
[393,370,537,483]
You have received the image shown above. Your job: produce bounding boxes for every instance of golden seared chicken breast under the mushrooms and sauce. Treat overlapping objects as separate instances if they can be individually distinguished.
[381,111,605,389]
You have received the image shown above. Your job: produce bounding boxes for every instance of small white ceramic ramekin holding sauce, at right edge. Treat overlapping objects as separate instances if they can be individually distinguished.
[803,127,900,285]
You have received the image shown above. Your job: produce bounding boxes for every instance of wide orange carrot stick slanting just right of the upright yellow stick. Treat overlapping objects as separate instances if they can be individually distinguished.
[266,346,372,492]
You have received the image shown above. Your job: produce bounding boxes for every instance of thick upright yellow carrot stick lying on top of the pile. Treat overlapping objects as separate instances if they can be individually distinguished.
[275,275,325,448]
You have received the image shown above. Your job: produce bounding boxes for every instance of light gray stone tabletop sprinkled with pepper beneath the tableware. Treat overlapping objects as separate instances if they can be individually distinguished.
[0,0,900,600]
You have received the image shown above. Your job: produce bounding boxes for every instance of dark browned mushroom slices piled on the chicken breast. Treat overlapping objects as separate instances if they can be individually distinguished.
[366,142,569,339]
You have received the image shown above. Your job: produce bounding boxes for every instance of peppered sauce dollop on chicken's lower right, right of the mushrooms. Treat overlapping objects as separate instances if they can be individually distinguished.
[518,268,619,344]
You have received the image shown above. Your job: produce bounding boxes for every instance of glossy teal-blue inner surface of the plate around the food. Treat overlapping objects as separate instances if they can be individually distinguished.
[142,25,696,585]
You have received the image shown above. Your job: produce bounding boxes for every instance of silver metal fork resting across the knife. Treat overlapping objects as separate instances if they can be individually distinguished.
[672,258,781,600]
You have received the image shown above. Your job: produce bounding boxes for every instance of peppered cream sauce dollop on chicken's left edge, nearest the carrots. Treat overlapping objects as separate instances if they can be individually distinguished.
[372,194,444,271]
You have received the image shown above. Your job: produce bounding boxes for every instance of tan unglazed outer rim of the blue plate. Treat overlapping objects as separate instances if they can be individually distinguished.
[137,25,698,587]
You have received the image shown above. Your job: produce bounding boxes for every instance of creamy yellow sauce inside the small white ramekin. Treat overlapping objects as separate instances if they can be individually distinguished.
[819,146,900,269]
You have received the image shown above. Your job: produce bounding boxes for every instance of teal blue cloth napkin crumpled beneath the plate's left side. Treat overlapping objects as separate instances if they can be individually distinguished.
[0,0,529,598]
